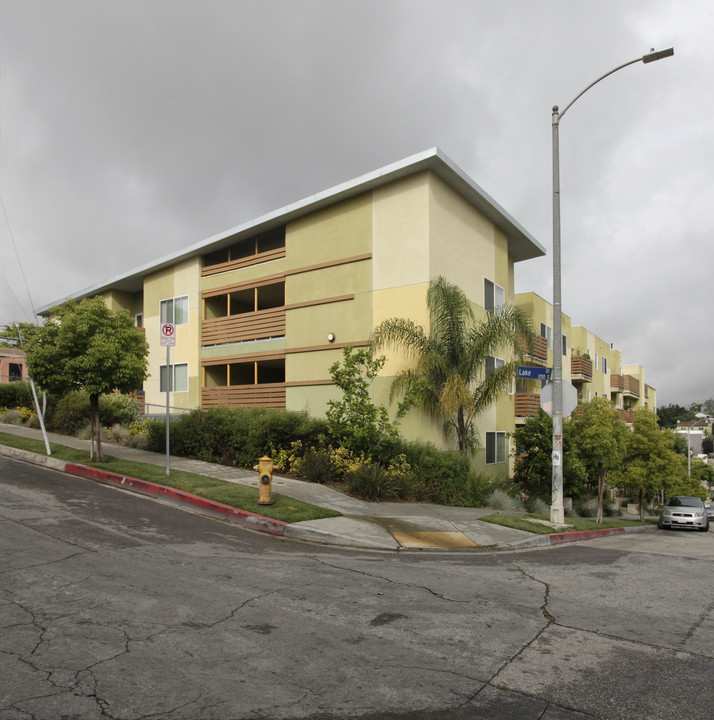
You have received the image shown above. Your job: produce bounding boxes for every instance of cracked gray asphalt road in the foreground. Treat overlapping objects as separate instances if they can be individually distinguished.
[0,458,714,720]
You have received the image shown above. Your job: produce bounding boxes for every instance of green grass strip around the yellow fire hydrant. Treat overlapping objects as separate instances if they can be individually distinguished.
[0,433,341,522]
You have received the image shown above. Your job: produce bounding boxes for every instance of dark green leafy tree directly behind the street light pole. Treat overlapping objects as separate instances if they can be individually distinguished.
[513,410,587,503]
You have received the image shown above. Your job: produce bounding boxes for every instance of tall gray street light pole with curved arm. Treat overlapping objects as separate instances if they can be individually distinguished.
[550,48,674,524]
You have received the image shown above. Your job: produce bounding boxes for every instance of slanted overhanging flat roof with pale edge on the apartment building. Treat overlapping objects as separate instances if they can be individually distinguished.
[36,148,545,315]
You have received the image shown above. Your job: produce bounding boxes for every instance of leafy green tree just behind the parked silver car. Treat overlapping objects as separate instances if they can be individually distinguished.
[618,408,682,522]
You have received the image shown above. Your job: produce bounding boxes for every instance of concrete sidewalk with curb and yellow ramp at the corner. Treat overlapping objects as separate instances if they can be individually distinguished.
[0,423,656,551]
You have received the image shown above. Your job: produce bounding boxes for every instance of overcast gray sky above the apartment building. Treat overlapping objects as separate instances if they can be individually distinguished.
[0,0,714,405]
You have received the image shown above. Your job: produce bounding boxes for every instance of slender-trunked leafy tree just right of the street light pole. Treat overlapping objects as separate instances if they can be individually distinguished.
[571,397,627,523]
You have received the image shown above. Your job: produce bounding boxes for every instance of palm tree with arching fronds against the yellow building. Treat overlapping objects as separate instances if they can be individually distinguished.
[372,277,533,454]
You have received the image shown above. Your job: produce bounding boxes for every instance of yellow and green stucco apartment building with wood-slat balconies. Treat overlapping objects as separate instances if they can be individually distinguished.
[39,149,654,472]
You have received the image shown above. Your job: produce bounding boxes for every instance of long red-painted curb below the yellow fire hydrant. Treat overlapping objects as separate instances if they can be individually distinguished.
[65,463,288,535]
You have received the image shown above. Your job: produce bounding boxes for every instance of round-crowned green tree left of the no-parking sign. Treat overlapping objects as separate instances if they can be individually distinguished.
[25,298,149,462]
